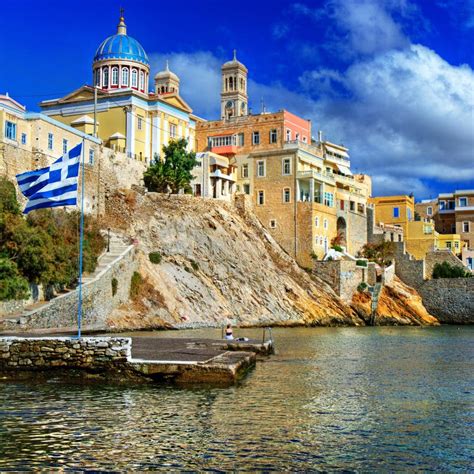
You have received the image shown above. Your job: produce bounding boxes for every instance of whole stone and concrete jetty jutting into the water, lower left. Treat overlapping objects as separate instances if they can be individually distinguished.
[0,336,274,385]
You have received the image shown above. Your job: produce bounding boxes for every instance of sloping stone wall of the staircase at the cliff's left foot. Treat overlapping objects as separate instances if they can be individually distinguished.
[0,246,138,331]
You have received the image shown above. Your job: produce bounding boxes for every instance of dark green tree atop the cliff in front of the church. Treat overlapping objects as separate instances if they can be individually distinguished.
[143,138,197,194]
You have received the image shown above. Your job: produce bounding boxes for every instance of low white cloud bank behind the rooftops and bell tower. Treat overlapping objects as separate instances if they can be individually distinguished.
[151,45,474,198]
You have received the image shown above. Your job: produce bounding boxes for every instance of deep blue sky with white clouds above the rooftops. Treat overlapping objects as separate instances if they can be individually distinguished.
[0,0,474,200]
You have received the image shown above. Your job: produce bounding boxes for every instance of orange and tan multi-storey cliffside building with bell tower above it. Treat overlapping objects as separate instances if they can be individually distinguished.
[196,52,371,267]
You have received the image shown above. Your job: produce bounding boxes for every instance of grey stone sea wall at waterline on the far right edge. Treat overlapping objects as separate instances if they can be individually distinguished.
[418,277,474,324]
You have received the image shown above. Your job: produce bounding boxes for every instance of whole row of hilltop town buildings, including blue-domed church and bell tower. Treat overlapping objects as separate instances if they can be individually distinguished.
[0,12,474,330]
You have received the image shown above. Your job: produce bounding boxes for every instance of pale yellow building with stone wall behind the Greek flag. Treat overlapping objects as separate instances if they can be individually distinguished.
[0,95,145,216]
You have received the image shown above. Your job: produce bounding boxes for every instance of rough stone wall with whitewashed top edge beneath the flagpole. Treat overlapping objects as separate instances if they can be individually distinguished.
[0,337,132,375]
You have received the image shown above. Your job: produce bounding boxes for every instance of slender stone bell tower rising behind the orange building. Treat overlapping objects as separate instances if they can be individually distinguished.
[221,49,248,119]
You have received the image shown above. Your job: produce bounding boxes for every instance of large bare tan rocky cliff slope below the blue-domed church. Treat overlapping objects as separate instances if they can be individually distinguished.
[103,192,436,329]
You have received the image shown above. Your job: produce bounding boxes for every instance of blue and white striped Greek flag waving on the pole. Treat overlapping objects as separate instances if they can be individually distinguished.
[16,143,82,214]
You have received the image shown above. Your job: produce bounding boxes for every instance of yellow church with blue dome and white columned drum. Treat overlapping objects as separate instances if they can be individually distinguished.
[40,12,200,162]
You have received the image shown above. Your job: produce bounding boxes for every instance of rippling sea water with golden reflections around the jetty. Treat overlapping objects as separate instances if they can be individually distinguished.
[0,327,474,471]
